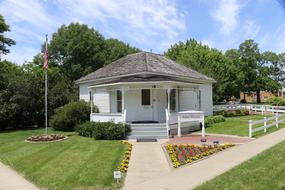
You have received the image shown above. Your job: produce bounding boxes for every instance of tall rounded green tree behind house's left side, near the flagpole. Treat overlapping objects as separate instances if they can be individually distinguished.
[48,23,105,80]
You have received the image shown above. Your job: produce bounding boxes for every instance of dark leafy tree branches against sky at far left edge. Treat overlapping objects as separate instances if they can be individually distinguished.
[0,15,16,58]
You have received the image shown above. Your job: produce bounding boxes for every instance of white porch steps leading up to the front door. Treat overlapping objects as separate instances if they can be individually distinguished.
[128,123,167,139]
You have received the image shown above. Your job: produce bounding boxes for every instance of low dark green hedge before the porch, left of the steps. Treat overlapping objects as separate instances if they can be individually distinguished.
[75,121,130,140]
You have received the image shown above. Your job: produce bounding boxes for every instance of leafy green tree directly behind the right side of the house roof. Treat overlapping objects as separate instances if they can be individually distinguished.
[165,39,239,102]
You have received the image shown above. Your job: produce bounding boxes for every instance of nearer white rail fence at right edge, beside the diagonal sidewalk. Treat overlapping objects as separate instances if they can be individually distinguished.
[248,113,285,138]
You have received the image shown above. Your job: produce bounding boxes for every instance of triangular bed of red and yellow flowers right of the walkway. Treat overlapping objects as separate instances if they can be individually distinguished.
[166,144,234,168]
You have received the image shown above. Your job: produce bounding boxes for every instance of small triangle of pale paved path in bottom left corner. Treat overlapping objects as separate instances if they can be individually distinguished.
[0,162,38,190]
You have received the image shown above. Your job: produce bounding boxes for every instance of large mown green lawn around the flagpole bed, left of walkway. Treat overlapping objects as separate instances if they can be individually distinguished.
[0,129,126,190]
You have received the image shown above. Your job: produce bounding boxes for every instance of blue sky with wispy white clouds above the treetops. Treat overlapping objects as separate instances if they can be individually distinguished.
[0,0,285,64]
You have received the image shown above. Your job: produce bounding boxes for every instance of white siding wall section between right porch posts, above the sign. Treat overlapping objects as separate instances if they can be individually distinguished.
[179,90,198,111]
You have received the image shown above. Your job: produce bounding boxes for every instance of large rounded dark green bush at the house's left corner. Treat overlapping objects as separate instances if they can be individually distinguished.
[49,101,98,131]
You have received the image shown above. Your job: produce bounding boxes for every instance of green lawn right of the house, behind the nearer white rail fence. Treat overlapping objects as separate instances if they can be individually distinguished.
[206,115,285,137]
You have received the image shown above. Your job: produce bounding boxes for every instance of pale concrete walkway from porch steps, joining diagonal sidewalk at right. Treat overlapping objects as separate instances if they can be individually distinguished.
[124,129,285,190]
